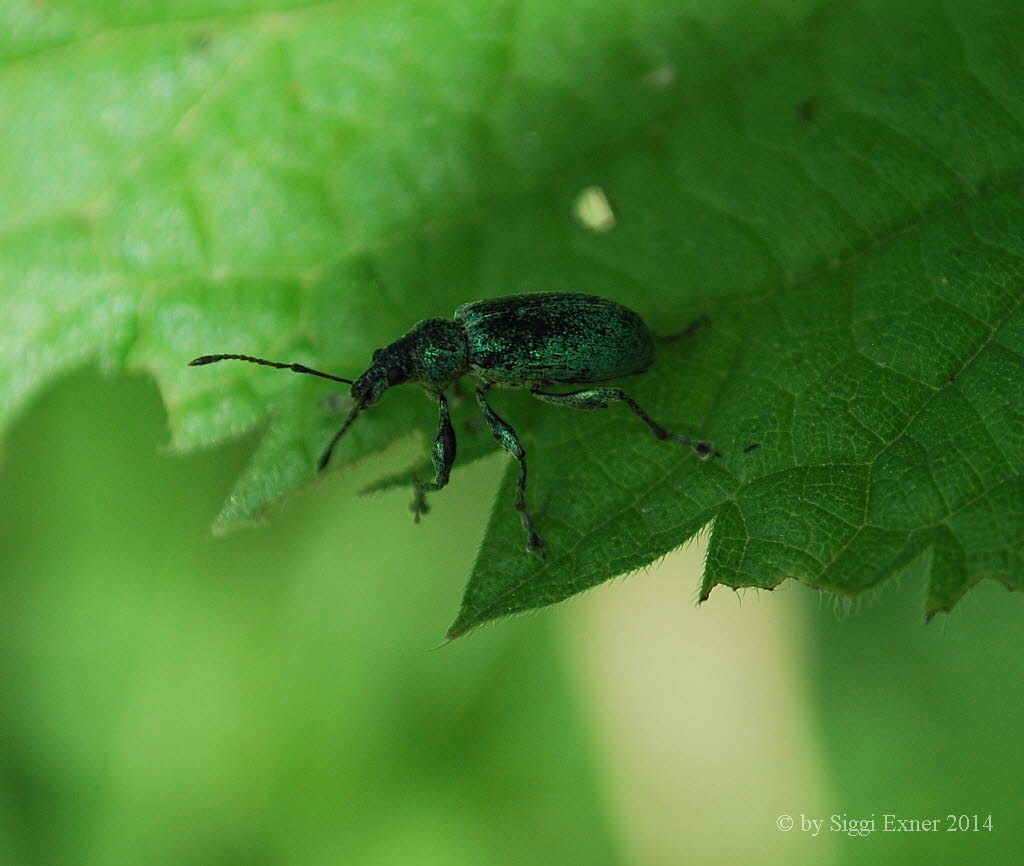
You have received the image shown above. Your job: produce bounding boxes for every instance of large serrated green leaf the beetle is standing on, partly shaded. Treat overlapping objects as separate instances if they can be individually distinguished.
[0,0,1024,635]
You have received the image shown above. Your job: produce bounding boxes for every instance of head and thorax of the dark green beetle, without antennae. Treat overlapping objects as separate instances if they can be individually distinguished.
[352,318,469,405]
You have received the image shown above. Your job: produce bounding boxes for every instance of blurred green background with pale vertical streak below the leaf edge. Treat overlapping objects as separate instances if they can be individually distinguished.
[0,370,1024,866]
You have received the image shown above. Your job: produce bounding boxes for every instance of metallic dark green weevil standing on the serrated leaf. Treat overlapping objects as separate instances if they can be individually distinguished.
[189,292,718,552]
